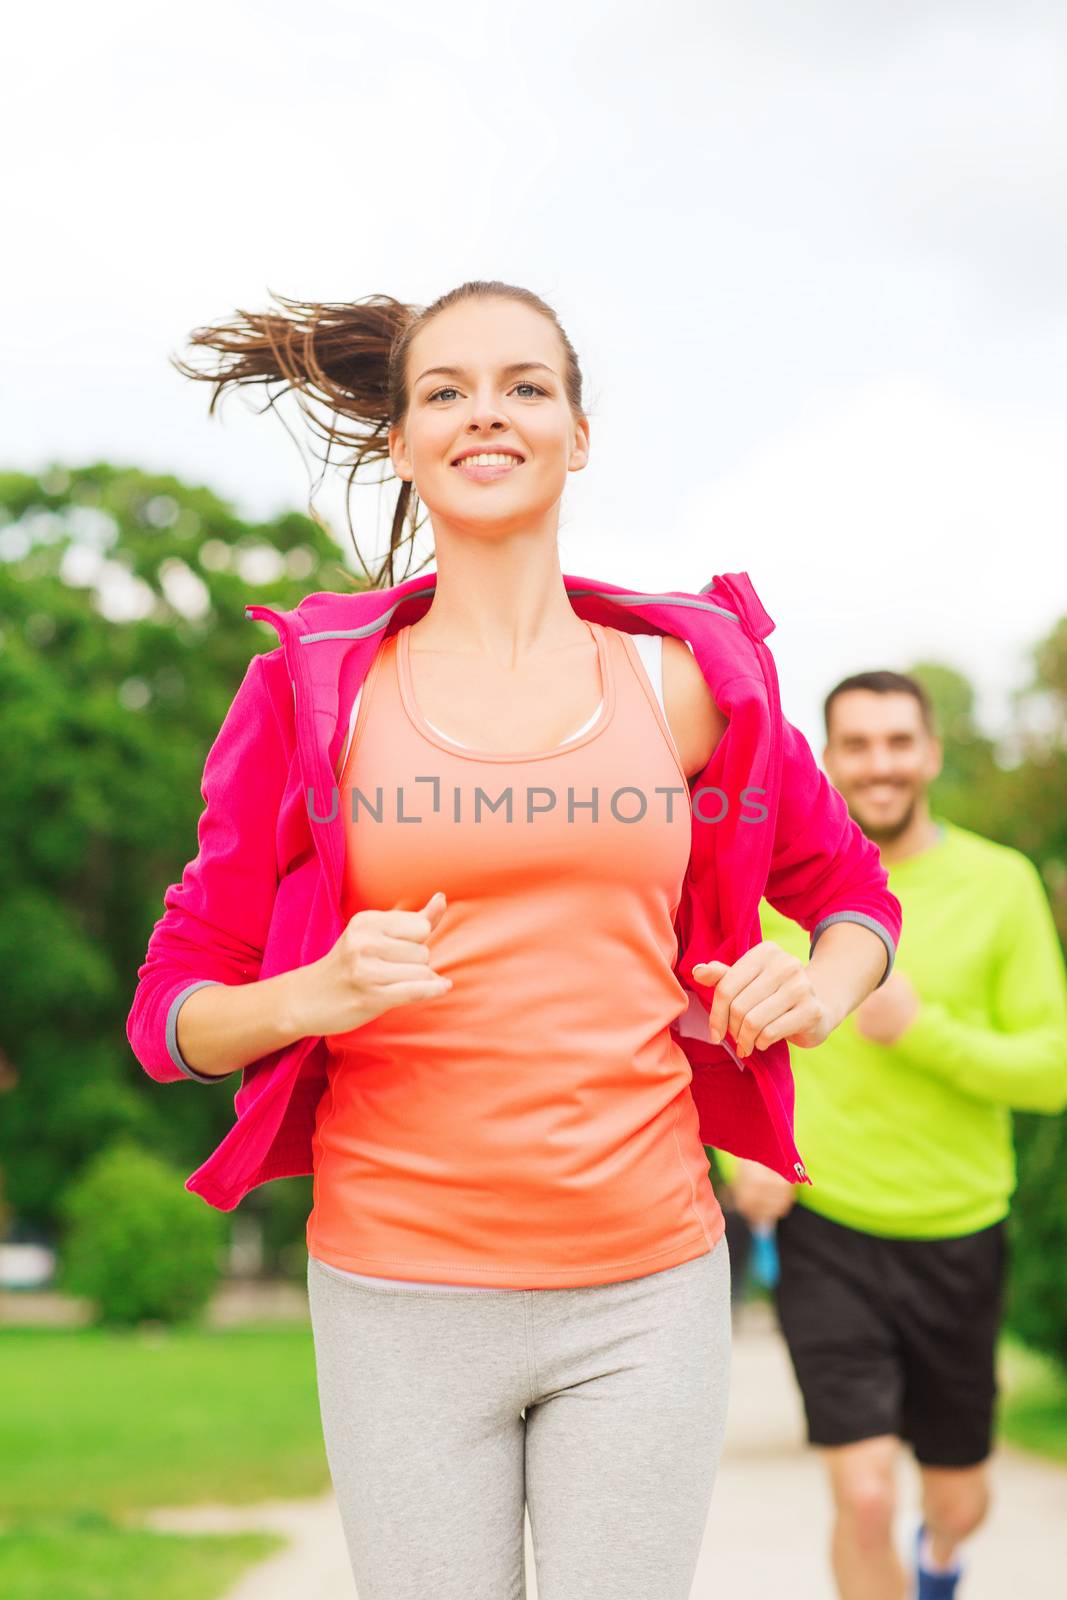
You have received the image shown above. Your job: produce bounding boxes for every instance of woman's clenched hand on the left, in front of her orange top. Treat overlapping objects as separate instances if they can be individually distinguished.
[301,890,453,1037]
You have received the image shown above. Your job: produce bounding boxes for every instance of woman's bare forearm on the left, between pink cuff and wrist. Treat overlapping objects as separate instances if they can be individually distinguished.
[176,966,310,1078]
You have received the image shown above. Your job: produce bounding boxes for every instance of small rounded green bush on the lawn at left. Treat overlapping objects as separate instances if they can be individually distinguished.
[56,1139,229,1326]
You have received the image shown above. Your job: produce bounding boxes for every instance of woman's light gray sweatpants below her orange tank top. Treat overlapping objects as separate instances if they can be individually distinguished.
[307,1238,729,1600]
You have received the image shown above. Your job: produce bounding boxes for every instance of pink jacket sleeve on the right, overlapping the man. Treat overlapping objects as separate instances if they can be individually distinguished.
[765,718,901,989]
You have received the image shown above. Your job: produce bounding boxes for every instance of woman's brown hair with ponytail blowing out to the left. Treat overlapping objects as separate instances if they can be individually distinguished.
[173,280,585,589]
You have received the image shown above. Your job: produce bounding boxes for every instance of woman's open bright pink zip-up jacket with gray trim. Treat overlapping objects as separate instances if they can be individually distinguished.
[126,573,901,1211]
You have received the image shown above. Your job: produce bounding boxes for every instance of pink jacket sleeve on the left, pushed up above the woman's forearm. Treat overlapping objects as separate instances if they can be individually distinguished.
[126,646,290,1083]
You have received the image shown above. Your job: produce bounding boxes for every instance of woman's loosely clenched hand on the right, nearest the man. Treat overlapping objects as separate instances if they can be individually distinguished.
[693,939,840,1056]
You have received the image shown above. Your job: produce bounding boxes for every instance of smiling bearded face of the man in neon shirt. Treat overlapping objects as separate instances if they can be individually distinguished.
[822,690,941,845]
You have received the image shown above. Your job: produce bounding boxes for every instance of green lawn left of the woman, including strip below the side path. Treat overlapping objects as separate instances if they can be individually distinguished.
[0,1323,330,1600]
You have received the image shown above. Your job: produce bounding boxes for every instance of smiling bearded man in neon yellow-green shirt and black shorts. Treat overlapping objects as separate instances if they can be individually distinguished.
[721,672,1067,1600]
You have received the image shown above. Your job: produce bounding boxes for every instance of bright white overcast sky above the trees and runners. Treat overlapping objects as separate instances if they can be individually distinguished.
[0,0,1067,749]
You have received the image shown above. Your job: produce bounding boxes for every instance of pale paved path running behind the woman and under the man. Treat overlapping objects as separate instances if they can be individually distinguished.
[141,1307,1067,1600]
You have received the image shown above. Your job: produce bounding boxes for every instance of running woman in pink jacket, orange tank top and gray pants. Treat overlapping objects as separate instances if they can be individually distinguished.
[128,283,901,1600]
